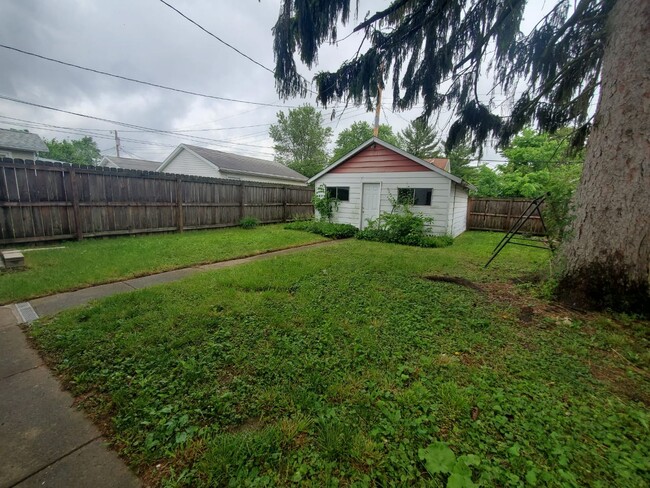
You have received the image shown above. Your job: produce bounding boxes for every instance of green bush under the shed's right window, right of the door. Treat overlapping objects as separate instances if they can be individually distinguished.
[357,205,454,247]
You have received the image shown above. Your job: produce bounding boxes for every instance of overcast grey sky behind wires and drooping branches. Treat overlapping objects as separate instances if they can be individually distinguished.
[0,0,540,166]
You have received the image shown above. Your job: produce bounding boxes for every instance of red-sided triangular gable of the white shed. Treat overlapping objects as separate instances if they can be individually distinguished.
[330,144,430,173]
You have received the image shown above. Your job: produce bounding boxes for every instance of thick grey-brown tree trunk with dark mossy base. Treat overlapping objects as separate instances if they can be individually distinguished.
[559,0,650,314]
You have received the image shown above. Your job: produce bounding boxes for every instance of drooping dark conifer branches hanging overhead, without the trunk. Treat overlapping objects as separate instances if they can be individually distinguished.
[274,0,616,149]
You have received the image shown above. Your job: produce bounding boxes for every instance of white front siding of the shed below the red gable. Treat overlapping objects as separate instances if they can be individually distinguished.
[314,171,452,234]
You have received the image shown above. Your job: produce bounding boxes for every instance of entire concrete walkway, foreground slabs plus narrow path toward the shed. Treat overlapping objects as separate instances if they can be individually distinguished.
[0,241,337,488]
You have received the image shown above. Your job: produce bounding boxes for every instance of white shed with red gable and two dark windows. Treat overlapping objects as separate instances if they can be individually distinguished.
[309,137,472,237]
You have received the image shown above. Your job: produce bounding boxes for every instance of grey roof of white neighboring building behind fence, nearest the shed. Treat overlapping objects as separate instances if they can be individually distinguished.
[160,144,307,183]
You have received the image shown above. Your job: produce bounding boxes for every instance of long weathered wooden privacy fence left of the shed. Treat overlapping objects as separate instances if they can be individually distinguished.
[0,158,314,244]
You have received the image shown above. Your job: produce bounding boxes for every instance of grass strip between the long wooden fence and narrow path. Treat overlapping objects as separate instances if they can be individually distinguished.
[0,225,326,304]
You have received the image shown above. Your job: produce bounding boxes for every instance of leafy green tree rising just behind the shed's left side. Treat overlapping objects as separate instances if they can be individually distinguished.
[269,105,332,178]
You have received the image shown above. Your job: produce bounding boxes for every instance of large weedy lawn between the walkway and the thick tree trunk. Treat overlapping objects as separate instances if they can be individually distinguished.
[30,233,650,488]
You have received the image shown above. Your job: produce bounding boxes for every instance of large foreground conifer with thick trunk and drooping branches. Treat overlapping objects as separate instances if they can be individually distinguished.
[274,0,650,313]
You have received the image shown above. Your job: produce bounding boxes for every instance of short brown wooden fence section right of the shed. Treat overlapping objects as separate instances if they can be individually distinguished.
[467,198,545,235]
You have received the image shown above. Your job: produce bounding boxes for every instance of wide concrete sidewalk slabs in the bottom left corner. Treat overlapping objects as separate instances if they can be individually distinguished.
[0,306,140,488]
